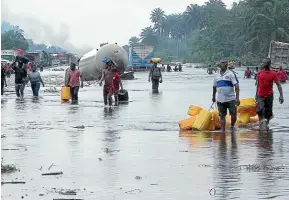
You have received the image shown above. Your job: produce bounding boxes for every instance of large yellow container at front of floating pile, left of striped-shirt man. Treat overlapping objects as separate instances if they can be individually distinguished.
[192,109,212,131]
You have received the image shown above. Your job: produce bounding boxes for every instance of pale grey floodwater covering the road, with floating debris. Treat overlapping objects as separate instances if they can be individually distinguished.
[1,68,289,200]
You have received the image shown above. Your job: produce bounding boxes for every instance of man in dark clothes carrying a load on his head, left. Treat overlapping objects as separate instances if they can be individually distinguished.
[10,59,28,100]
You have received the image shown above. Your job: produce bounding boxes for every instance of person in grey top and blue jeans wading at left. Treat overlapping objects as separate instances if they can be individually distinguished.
[28,64,44,99]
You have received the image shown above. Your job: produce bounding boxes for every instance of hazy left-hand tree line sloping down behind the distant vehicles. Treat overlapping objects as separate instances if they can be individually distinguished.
[1,22,66,53]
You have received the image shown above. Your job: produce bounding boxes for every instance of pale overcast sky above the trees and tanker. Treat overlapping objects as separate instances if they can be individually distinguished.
[1,0,239,53]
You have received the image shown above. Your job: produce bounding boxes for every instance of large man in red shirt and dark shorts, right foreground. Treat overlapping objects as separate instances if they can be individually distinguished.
[256,60,284,129]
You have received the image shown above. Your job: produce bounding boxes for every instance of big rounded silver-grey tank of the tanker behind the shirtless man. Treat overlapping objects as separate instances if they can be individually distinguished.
[79,44,128,81]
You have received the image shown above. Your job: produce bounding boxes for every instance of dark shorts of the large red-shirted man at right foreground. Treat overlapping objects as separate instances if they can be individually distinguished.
[257,94,274,119]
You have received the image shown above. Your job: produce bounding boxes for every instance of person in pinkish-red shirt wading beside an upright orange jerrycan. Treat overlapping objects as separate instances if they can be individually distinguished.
[66,63,83,103]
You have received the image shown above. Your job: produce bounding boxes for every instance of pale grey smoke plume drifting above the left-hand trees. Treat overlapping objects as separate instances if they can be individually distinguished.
[1,3,92,55]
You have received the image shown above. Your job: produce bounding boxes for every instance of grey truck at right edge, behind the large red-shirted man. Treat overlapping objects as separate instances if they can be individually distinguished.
[268,41,289,76]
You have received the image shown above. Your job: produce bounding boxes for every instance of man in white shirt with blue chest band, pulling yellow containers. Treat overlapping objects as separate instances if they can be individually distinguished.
[212,61,240,131]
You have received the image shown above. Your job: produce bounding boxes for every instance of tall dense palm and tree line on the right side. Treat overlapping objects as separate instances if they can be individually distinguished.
[128,0,289,64]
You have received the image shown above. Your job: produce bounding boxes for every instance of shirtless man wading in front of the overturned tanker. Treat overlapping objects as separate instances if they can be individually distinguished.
[99,57,115,106]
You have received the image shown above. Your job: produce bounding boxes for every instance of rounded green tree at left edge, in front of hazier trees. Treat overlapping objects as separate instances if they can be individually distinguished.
[1,29,29,51]
